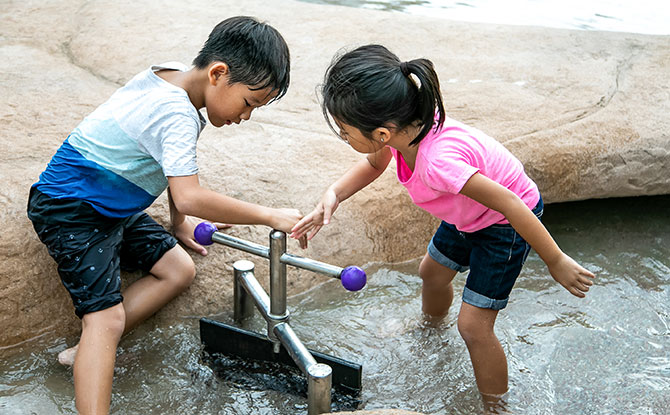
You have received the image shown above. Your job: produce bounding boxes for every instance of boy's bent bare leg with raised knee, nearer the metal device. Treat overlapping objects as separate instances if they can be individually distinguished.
[123,245,195,333]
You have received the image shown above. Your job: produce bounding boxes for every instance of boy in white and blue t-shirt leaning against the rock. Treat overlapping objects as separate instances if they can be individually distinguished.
[28,17,301,414]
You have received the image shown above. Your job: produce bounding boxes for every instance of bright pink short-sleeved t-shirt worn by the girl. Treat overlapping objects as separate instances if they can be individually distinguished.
[391,118,540,232]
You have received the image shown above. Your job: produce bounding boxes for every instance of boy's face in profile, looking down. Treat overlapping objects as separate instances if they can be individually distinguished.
[205,63,277,127]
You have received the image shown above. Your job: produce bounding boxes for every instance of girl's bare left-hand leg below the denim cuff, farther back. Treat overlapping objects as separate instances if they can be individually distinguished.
[419,254,456,323]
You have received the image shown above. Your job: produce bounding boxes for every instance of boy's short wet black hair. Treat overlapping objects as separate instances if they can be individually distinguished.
[193,16,291,101]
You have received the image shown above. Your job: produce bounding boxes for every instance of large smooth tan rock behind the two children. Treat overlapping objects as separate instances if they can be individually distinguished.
[0,0,670,358]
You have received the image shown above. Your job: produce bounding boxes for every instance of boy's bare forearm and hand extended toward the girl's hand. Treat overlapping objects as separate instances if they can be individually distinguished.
[168,175,302,232]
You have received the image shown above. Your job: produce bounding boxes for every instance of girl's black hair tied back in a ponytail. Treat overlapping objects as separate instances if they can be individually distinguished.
[321,45,444,145]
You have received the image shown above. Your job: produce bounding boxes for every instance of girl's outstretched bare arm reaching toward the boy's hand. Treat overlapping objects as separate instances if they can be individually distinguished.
[291,147,391,240]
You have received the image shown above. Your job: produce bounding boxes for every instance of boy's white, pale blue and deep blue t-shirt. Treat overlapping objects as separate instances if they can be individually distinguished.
[34,62,206,218]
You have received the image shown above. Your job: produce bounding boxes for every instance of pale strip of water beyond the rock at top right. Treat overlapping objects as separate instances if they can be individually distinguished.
[302,0,670,35]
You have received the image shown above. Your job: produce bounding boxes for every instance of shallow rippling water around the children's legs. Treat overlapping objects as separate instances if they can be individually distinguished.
[0,196,670,415]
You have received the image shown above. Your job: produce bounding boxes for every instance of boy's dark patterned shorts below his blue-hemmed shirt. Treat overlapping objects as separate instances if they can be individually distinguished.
[29,192,177,318]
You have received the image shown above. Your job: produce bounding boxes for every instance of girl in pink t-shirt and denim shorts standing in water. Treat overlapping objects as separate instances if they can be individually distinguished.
[291,45,594,407]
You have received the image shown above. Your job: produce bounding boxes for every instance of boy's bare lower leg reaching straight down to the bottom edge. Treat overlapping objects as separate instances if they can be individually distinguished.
[74,304,126,415]
